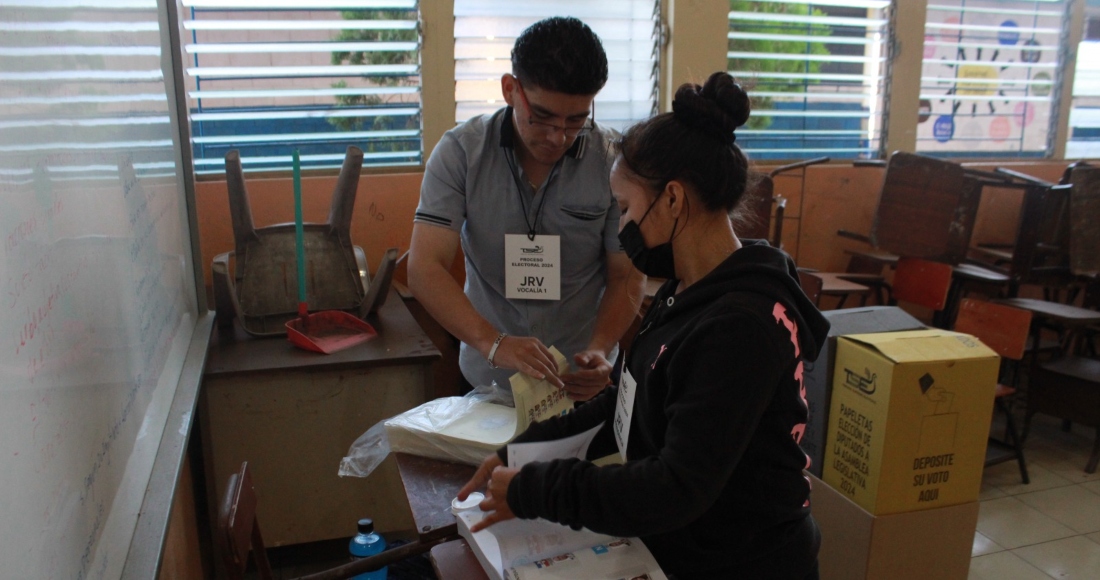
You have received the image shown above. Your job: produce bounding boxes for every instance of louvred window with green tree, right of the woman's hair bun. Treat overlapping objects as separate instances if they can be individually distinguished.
[726,0,890,160]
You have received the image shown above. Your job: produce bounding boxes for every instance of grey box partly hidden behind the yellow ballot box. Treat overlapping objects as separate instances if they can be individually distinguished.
[799,306,924,478]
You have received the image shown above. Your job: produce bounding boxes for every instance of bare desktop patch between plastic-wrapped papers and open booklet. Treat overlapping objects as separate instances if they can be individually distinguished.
[394,453,477,541]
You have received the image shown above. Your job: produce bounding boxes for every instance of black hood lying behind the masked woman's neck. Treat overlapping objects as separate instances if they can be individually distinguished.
[653,240,829,361]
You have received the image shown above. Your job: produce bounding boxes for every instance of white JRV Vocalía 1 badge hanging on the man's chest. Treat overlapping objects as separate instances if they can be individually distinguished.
[504,233,561,300]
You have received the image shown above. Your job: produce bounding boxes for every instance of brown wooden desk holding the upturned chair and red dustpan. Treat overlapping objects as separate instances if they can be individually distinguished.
[199,291,439,547]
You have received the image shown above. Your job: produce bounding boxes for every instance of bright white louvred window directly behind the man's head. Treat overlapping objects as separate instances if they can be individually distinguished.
[454,0,660,130]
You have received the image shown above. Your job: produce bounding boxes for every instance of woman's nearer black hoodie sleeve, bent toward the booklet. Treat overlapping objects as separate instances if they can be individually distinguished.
[508,313,793,536]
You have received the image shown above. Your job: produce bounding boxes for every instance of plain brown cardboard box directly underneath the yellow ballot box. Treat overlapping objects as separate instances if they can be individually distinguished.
[810,475,978,580]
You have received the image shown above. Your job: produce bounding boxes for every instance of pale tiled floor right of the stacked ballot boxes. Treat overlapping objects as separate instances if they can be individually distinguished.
[970,416,1100,580]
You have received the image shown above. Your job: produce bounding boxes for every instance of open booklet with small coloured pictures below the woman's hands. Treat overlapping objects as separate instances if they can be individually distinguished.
[457,510,668,580]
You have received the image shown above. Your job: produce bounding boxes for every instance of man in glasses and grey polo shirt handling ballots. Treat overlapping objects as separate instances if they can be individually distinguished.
[409,18,642,401]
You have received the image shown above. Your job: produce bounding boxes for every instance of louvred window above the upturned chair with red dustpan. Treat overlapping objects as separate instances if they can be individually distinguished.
[183,0,422,173]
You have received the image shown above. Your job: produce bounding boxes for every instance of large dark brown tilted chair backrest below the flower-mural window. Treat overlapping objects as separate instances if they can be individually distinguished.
[871,152,981,264]
